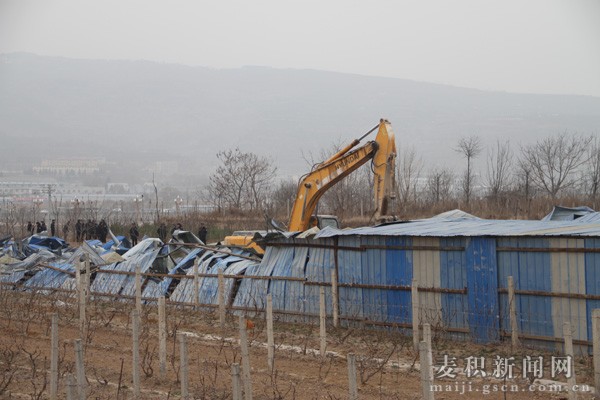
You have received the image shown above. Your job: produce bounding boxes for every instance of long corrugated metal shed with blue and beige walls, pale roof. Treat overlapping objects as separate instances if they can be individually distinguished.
[254,210,600,349]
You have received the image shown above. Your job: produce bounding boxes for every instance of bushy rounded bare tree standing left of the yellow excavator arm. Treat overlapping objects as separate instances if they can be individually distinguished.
[208,148,277,210]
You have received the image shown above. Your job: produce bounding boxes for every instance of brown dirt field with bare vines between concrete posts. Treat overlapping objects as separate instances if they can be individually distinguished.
[0,290,592,400]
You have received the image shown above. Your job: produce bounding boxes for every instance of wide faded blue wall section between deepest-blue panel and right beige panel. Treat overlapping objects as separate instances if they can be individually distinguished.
[497,238,554,337]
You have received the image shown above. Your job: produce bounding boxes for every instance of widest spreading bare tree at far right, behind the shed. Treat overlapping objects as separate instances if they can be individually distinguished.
[521,132,592,199]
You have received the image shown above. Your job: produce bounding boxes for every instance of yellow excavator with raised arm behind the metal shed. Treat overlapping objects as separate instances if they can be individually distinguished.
[223,119,396,254]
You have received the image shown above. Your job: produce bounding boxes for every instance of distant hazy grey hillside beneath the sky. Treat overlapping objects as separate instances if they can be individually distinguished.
[0,53,600,174]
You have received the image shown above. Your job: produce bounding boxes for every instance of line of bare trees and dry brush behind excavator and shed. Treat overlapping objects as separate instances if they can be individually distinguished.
[205,132,600,221]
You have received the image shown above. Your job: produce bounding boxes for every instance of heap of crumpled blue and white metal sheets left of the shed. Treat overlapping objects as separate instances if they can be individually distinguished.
[0,230,260,304]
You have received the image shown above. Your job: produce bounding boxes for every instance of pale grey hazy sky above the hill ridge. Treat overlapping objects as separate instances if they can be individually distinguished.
[0,0,600,96]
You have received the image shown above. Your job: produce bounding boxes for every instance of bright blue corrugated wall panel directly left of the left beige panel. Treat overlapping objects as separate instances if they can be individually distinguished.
[381,237,413,323]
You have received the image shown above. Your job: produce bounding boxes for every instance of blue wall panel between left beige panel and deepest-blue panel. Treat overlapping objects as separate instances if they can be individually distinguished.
[440,238,469,328]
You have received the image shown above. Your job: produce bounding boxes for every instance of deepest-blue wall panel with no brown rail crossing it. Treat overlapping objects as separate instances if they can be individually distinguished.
[466,237,499,343]
